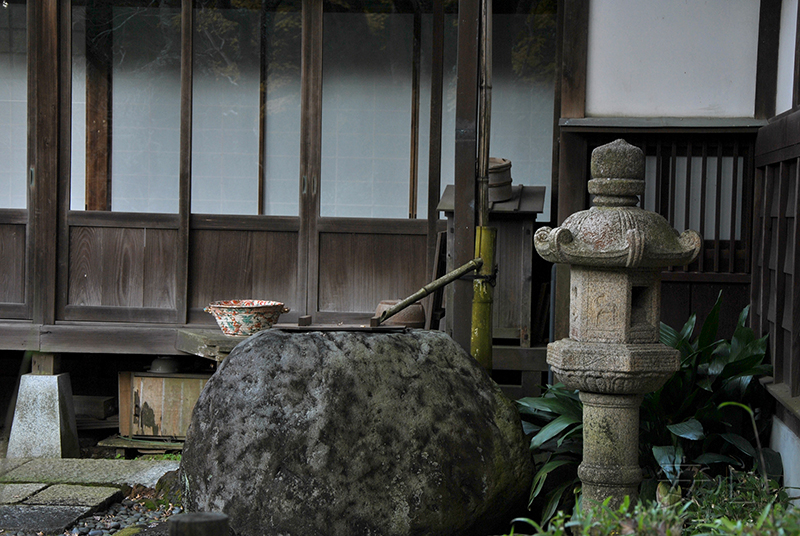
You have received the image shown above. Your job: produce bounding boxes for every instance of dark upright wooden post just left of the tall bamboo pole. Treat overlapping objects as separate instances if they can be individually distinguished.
[454,0,480,351]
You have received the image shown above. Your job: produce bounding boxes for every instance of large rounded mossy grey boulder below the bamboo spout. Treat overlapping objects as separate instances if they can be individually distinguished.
[181,330,532,536]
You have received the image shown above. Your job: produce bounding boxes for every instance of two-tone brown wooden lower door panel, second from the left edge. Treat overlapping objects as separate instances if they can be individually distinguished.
[67,227,177,309]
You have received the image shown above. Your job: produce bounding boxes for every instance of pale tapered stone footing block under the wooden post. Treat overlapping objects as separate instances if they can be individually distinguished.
[6,373,81,458]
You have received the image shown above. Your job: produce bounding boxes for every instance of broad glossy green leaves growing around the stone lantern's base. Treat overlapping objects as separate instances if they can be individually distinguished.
[517,294,783,523]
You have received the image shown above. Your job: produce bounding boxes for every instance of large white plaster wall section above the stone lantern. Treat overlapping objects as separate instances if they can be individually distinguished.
[586,0,759,117]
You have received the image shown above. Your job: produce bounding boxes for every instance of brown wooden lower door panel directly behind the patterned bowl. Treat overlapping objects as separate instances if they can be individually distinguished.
[189,230,301,312]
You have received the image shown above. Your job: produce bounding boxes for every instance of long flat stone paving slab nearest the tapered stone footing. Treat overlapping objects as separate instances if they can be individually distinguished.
[0,458,180,488]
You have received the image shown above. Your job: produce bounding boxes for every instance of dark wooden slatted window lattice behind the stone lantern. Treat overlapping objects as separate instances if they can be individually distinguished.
[589,131,755,283]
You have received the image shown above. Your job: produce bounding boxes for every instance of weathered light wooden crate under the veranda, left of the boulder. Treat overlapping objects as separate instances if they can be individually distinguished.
[119,372,211,439]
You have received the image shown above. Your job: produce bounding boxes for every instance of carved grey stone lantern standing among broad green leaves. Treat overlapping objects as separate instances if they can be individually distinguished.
[534,140,702,506]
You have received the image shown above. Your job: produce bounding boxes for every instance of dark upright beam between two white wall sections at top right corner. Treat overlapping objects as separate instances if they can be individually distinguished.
[755,0,781,119]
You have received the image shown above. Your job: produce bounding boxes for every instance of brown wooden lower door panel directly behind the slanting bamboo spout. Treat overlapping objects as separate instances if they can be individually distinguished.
[318,233,428,313]
